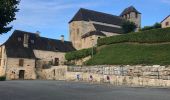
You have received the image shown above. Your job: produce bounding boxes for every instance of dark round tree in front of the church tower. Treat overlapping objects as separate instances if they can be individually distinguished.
[122,21,137,33]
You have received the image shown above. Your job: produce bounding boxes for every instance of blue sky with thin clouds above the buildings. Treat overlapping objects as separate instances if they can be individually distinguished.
[0,0,170,44]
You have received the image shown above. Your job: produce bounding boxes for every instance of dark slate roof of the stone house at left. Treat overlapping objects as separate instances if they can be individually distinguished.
[3,30,75,58]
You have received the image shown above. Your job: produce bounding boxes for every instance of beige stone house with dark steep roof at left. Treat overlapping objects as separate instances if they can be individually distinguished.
[0,30,75,80]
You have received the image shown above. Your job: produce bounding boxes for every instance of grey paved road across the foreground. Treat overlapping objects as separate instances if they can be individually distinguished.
[0,80,170,100]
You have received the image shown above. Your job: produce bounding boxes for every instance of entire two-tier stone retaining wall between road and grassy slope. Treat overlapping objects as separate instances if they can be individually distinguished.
[42,65,170,87]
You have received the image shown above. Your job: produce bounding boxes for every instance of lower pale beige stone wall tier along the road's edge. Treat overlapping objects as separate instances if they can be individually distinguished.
[66,72,170,87]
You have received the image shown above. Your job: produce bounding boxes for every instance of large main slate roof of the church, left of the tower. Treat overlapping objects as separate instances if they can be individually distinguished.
[69,8,124,26]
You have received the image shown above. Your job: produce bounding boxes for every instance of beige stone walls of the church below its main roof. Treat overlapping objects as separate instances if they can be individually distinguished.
[69,21,121,50]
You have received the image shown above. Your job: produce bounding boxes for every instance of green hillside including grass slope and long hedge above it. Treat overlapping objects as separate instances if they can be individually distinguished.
[65,28,170,65]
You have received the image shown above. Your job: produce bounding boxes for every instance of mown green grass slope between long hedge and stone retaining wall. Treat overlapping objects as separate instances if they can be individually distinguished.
[86,43,170,65]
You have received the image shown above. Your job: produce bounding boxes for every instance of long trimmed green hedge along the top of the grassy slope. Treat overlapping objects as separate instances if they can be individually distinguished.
[98,28,170,46]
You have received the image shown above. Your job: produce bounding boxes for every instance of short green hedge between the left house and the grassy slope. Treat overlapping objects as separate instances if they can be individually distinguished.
[65,48,96,61]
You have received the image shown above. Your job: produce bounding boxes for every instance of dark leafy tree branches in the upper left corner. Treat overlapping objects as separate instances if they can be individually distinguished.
[0,0,20,34]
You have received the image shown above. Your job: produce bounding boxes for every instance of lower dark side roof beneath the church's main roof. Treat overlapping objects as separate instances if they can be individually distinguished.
[93,24,123,34]
